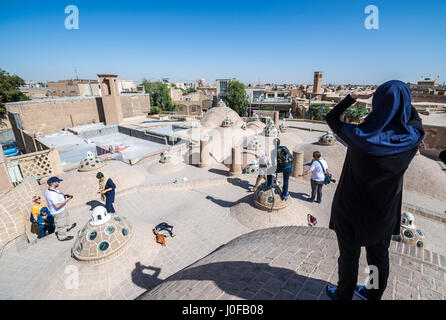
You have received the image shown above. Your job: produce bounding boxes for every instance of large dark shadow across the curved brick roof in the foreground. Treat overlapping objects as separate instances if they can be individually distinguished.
[137,261,329,300]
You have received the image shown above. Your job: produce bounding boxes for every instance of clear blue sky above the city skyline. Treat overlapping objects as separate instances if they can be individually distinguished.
[0,0,446,84]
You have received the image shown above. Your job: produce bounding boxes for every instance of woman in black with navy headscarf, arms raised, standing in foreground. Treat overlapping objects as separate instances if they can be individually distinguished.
[326,81,424,300]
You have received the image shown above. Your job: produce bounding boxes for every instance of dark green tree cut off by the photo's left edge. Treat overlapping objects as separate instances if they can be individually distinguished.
[0,69,30,116]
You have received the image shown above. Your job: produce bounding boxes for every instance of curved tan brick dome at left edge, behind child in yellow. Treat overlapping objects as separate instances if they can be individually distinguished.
[0,179,46,248]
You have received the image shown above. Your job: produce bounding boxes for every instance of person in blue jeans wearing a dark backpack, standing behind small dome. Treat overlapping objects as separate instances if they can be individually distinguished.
[266,138,294,201]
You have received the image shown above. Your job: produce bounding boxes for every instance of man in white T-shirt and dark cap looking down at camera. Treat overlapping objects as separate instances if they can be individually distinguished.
[45,177,76,241]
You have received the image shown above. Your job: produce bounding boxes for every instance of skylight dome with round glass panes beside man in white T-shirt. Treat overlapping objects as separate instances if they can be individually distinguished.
[71,206,133,264]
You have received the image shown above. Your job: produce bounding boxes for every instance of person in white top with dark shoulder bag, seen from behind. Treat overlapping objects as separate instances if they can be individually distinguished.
[301,151,331,204]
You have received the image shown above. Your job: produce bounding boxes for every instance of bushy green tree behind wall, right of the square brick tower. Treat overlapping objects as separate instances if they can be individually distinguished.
[142,79,178,113]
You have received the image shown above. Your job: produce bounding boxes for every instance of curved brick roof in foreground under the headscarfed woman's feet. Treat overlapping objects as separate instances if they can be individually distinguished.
[138,227,446,300]
